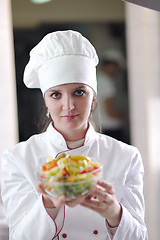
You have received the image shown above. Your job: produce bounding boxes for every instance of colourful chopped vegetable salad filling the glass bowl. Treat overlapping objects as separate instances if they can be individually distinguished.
[40,153,101,200]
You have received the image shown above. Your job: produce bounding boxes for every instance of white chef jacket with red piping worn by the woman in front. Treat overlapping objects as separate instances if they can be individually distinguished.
[1,124,148,240]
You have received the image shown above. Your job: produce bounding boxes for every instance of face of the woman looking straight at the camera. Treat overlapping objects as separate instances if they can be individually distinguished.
[44,83,94,140]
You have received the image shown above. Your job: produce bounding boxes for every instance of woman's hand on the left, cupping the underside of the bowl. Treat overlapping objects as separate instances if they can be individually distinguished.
[38,183,84,208]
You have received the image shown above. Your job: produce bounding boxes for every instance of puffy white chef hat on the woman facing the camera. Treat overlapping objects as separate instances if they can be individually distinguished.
[23,30,99,94]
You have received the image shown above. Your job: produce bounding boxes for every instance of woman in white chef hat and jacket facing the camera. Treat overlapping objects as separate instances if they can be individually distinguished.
[2,30,148,240]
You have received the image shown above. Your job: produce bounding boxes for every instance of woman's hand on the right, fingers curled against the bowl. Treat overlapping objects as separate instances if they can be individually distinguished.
[81,180,122,227]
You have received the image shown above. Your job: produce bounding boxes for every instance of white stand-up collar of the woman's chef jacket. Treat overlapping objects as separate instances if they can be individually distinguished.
[46,123,97,151]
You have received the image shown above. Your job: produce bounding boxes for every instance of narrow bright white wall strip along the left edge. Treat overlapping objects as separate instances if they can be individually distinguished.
[0,0,18,159]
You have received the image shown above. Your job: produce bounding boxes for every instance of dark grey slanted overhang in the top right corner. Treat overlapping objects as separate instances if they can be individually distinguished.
[123,0,160,11]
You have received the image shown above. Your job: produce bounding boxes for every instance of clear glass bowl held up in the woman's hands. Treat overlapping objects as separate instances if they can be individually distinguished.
[39,156,102,201]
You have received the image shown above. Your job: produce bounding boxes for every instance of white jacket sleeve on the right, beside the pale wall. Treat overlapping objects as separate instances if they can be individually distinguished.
[107,150,148,240]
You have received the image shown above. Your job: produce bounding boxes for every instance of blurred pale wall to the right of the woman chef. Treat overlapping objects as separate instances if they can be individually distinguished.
[126,3,160,240]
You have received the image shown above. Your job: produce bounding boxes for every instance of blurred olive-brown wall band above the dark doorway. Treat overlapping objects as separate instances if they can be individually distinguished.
[12,0,124,27]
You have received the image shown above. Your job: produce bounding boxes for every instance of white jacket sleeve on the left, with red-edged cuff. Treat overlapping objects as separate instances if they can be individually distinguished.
[1,151,64,240]
